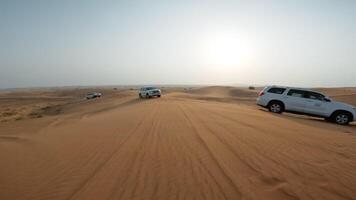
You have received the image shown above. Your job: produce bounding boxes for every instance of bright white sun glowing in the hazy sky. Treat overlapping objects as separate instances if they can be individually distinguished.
[203,32,254,66]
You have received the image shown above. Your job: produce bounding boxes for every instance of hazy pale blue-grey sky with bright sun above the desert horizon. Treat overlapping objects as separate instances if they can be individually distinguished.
[0,0,356,88]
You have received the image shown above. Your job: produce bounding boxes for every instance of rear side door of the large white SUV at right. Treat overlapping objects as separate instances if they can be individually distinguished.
[284,89,306,112]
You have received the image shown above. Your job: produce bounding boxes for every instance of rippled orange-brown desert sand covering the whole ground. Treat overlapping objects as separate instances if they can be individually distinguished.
[0,86,356,200]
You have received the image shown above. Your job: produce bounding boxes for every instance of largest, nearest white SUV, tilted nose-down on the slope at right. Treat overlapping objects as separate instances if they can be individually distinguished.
[257,86,356,125]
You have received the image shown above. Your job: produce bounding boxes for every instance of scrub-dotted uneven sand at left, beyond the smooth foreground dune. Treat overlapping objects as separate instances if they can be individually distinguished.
[0,88,136,122]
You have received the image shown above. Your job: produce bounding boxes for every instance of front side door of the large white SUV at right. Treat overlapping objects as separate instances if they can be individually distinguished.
[305,91,330,116]
